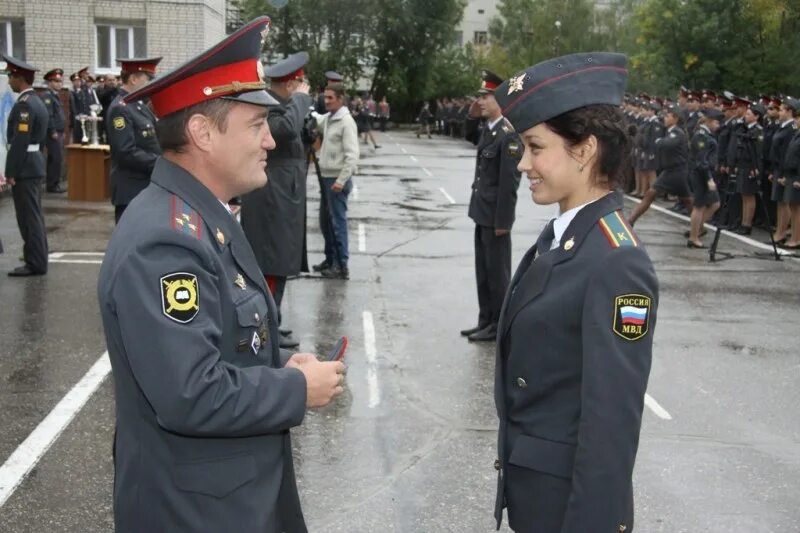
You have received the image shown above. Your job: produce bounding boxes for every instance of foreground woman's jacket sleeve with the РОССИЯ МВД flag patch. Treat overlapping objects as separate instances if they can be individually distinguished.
[561,247,658,533]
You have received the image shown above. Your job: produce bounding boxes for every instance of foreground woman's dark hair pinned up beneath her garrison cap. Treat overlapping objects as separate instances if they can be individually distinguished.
[545,104,632,190]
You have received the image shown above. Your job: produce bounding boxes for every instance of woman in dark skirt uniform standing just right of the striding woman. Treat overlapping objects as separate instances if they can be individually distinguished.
[686,108,725,248]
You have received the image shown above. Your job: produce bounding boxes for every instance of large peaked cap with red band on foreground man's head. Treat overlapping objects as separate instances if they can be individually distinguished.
[124,17,278,117]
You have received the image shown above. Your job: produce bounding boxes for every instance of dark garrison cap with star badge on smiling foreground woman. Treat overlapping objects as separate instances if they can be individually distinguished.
[495,52,628,132]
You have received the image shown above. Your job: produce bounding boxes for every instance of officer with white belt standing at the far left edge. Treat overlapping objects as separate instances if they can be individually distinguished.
[0,54,48,276]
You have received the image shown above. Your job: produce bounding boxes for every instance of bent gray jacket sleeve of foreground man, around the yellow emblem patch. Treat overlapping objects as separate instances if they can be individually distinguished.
[111,230,306,437]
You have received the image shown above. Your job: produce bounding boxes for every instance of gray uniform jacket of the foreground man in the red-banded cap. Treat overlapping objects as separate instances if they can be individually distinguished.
[98,159,306,533]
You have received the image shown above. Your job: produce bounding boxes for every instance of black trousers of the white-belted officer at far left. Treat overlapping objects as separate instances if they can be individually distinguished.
[11,178,47,274]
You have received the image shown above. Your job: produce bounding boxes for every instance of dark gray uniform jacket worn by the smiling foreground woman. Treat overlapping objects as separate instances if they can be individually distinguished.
[495,193,658,533]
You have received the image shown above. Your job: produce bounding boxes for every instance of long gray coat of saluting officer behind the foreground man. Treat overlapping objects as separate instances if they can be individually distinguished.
[242,92,312,276]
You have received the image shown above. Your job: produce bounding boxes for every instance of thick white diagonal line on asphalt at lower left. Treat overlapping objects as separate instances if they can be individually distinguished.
[0,352,111,507]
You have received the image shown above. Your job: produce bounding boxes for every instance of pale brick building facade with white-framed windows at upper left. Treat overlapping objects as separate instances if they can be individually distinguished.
[0,0,226,77]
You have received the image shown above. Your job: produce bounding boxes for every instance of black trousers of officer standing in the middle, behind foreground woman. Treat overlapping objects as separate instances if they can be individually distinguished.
[475,225,511,327]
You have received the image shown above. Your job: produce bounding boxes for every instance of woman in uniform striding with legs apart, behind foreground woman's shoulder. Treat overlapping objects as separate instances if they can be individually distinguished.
[629,107,692,225]
